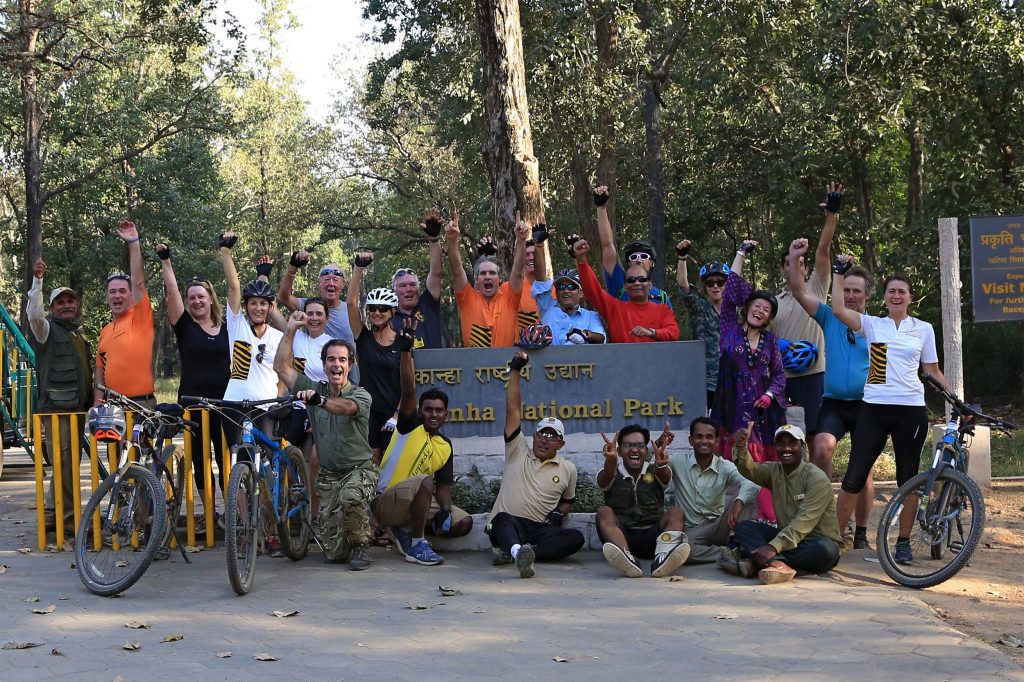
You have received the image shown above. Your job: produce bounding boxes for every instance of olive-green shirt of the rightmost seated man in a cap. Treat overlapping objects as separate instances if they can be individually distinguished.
[732,440,843,552]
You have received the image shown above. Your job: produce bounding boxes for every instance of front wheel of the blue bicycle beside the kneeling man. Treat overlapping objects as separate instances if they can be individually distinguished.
[224,462,259,595]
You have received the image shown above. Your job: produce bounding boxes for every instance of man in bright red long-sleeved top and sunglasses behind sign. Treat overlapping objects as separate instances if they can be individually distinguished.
[570,236,679,343]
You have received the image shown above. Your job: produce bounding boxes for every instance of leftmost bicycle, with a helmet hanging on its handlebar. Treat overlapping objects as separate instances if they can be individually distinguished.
[75,386,199,596]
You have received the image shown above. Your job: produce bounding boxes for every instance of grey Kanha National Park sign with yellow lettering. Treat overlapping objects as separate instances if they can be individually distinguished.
[407,341,707,438]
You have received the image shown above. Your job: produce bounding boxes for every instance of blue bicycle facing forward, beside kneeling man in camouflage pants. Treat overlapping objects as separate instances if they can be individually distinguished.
[181,395,323,595]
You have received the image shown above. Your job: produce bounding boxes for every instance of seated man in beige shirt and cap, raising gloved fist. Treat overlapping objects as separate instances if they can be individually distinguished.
[487,351,584,578]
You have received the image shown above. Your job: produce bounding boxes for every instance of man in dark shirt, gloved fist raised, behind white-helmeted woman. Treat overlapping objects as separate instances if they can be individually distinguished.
[391,209,443,348]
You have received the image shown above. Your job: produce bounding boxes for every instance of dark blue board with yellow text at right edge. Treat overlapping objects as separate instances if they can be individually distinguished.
[971,215,1024,322]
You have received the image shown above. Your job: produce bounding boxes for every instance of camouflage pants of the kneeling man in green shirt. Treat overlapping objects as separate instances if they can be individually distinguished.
[316,460,380,561]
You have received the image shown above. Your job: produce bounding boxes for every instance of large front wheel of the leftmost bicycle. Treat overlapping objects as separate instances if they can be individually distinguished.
[75,464,167,597]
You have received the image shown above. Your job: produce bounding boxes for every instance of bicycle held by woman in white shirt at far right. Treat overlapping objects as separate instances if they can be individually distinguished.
[877,375,1017,589]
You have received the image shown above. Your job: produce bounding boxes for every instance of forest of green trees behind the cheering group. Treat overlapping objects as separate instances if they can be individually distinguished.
[0,0,1024,404]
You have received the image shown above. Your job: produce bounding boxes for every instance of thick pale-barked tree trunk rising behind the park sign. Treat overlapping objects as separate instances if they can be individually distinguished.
[476,0,544,262]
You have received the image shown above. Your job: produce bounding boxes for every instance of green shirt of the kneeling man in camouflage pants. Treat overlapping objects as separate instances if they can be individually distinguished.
[292,374,374,472]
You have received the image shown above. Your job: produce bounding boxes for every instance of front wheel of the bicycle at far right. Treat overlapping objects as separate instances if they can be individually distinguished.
[877,469,985,589]
